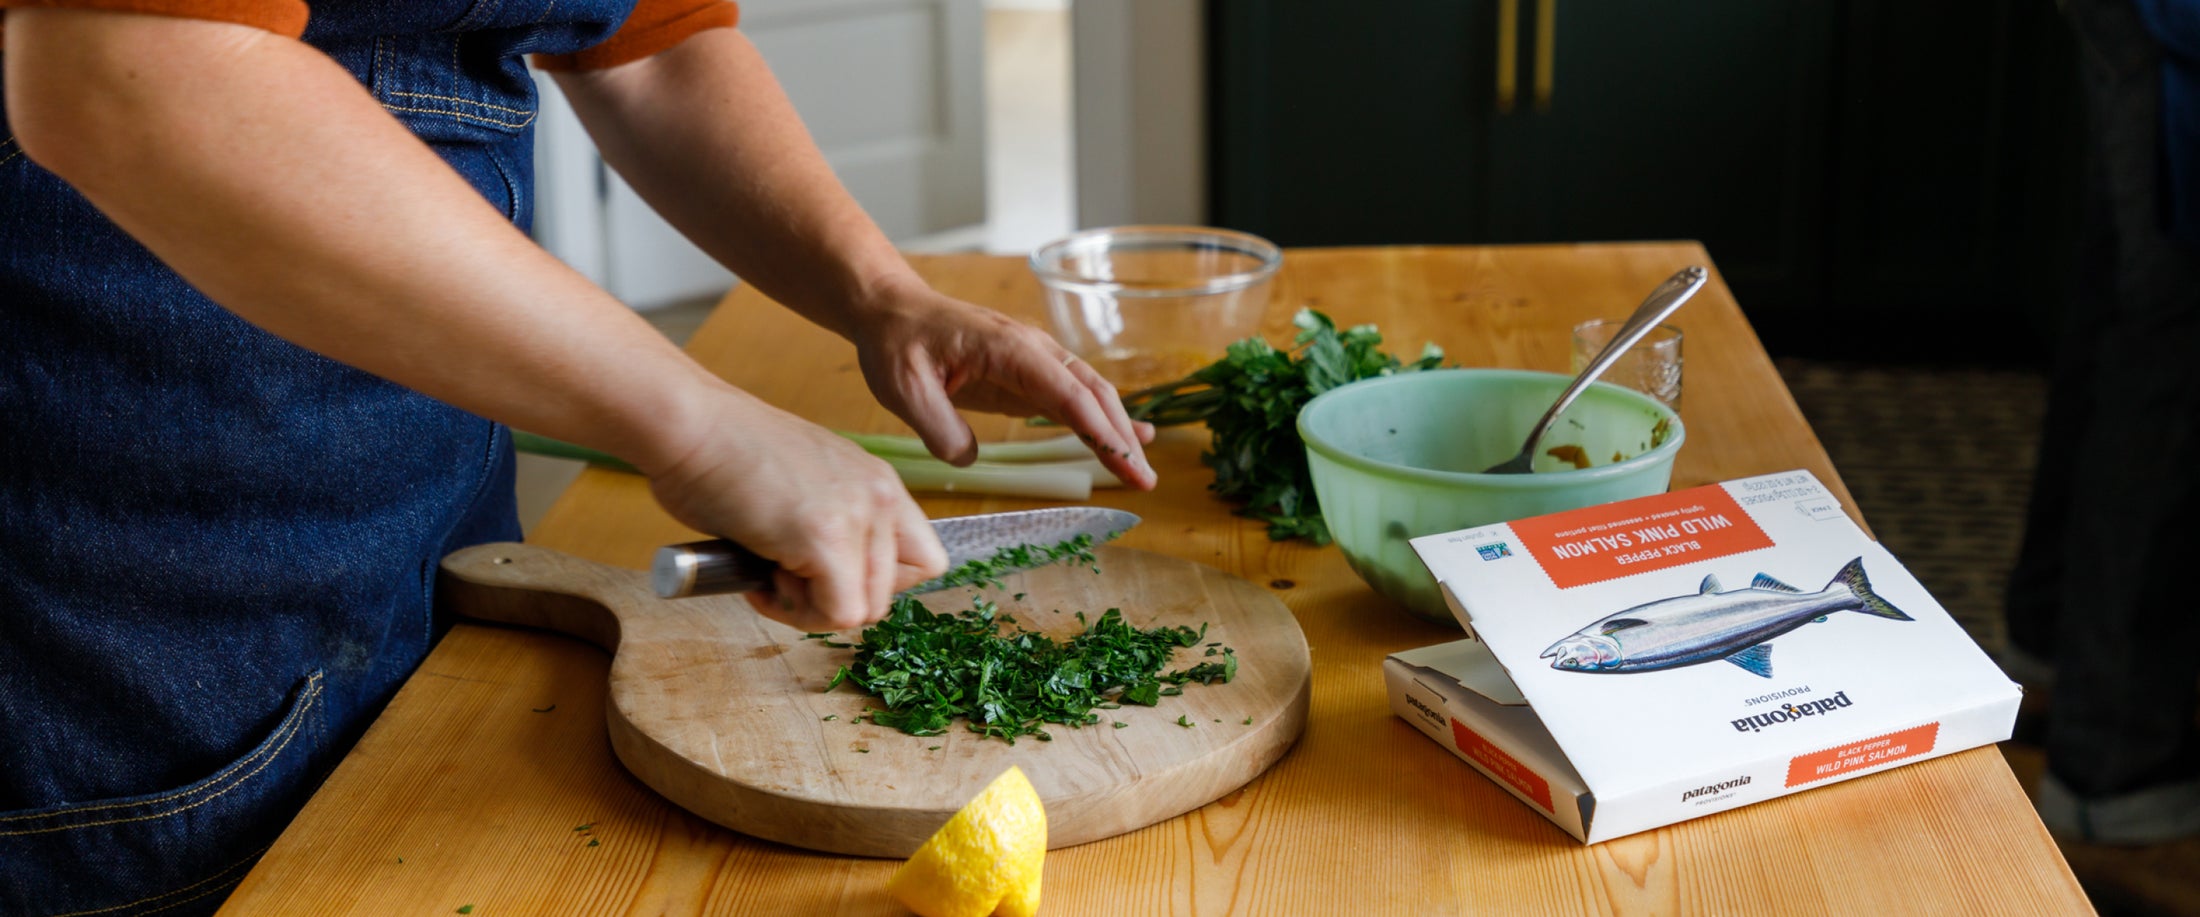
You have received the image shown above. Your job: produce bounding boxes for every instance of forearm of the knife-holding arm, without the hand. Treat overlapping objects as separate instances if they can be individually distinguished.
[0,9,730,468]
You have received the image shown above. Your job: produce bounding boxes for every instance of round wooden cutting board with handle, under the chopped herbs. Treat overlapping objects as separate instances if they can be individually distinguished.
[442,543,1311,858]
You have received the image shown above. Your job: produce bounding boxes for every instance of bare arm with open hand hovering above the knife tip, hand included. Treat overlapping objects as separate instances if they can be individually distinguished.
[559,29,1153,488]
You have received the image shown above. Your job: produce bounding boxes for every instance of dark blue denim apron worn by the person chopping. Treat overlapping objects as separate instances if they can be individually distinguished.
[0,0,634,915]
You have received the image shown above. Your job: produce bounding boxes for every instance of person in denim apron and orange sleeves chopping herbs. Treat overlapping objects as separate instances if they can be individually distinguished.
[0,0,1153,915]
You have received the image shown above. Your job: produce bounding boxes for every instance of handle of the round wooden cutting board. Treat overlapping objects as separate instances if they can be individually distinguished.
[436,541,658,651]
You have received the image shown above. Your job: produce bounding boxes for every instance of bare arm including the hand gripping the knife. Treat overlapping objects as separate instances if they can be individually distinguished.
[0,9,944,627]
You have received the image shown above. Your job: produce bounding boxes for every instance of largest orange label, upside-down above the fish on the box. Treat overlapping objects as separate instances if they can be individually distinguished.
[1511,484,1773,589]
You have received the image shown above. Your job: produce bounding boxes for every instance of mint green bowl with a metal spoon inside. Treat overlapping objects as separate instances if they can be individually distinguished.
[1298,369,1687,622]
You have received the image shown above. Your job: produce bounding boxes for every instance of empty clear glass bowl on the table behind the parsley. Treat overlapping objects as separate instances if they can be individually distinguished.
[1032,227,1283,389]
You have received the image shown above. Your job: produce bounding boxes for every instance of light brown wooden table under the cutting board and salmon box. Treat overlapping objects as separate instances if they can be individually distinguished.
[224,244,2090,917]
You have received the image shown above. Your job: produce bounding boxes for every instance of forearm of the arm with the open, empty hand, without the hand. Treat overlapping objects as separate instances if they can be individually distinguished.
[557,29,922,336]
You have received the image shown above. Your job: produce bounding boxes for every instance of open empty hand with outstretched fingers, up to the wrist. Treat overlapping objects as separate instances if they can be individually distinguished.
[854,281,1155,490]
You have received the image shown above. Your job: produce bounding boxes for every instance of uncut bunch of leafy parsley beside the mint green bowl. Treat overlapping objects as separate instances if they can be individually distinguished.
[1122,308,1443,545]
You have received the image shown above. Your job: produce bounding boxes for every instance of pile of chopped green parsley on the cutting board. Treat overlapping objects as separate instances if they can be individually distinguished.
[810,537,1236,743]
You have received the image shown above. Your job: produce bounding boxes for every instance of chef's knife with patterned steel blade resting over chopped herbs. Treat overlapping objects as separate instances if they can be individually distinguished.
[649,506,1137,598]
